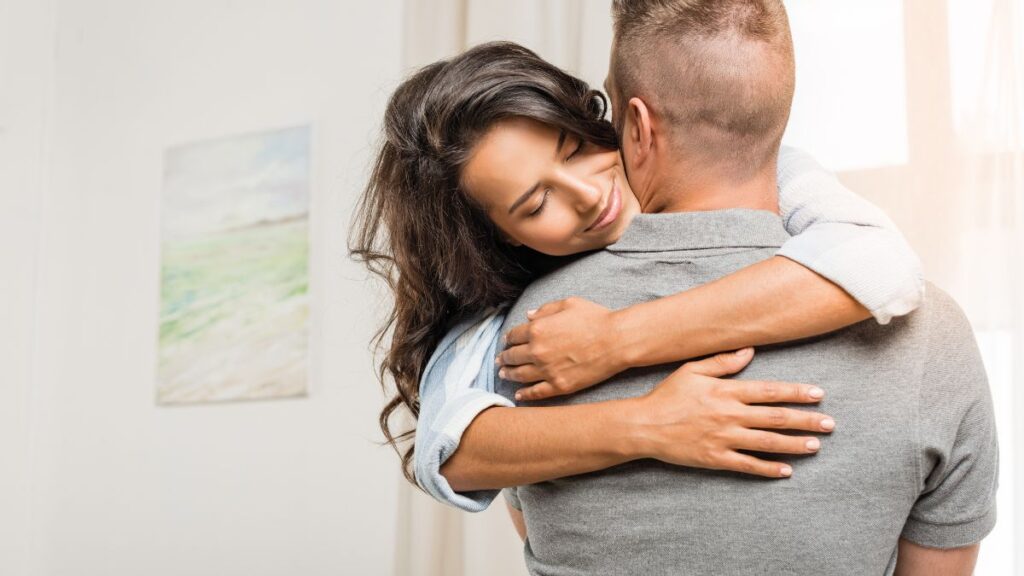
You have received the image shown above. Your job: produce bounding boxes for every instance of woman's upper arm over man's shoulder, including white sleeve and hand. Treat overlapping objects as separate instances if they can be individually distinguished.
[499,150,924,400]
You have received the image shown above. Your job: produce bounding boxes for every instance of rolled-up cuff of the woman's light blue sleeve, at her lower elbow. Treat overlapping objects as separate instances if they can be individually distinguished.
[415,390,514,512]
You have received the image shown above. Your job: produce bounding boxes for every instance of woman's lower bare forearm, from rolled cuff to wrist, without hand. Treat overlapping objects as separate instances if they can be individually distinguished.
[440,400,640,492]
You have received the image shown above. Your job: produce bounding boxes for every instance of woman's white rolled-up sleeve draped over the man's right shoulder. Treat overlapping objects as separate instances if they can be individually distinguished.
[778,147,925,324]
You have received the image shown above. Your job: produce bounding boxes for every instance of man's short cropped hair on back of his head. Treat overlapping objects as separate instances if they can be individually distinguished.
[609,0,796,175]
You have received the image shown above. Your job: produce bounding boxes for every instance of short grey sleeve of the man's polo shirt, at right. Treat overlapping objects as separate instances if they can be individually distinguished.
[902,297,999,548]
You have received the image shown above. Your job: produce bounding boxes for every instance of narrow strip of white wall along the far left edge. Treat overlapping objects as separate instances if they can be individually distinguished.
[0,0,54,575]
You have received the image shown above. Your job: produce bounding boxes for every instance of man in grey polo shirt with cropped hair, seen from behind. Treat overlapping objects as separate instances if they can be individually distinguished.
[417,0,996,574]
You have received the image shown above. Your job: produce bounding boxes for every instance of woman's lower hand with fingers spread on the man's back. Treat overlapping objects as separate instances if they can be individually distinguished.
[632,348,836,478]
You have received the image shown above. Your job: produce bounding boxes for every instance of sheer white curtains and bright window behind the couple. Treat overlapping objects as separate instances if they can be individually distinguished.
[387,0,1024,576]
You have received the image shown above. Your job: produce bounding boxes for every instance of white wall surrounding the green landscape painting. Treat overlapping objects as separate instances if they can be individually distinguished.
[16,0,401,576]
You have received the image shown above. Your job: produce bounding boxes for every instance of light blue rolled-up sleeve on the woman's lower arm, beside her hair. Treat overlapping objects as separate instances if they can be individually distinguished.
[414,311,514,512]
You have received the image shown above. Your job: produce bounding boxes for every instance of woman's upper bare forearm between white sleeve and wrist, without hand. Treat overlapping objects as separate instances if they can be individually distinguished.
[616,256,870,366]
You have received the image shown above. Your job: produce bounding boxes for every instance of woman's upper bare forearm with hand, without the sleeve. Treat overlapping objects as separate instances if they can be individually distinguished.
[499,256,870,401]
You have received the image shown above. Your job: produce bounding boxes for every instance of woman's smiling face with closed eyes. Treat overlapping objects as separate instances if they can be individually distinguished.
[462,118,640,256]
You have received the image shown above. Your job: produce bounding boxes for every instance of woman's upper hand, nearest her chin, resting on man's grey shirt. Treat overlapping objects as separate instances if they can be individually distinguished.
[497,297,628,400]
